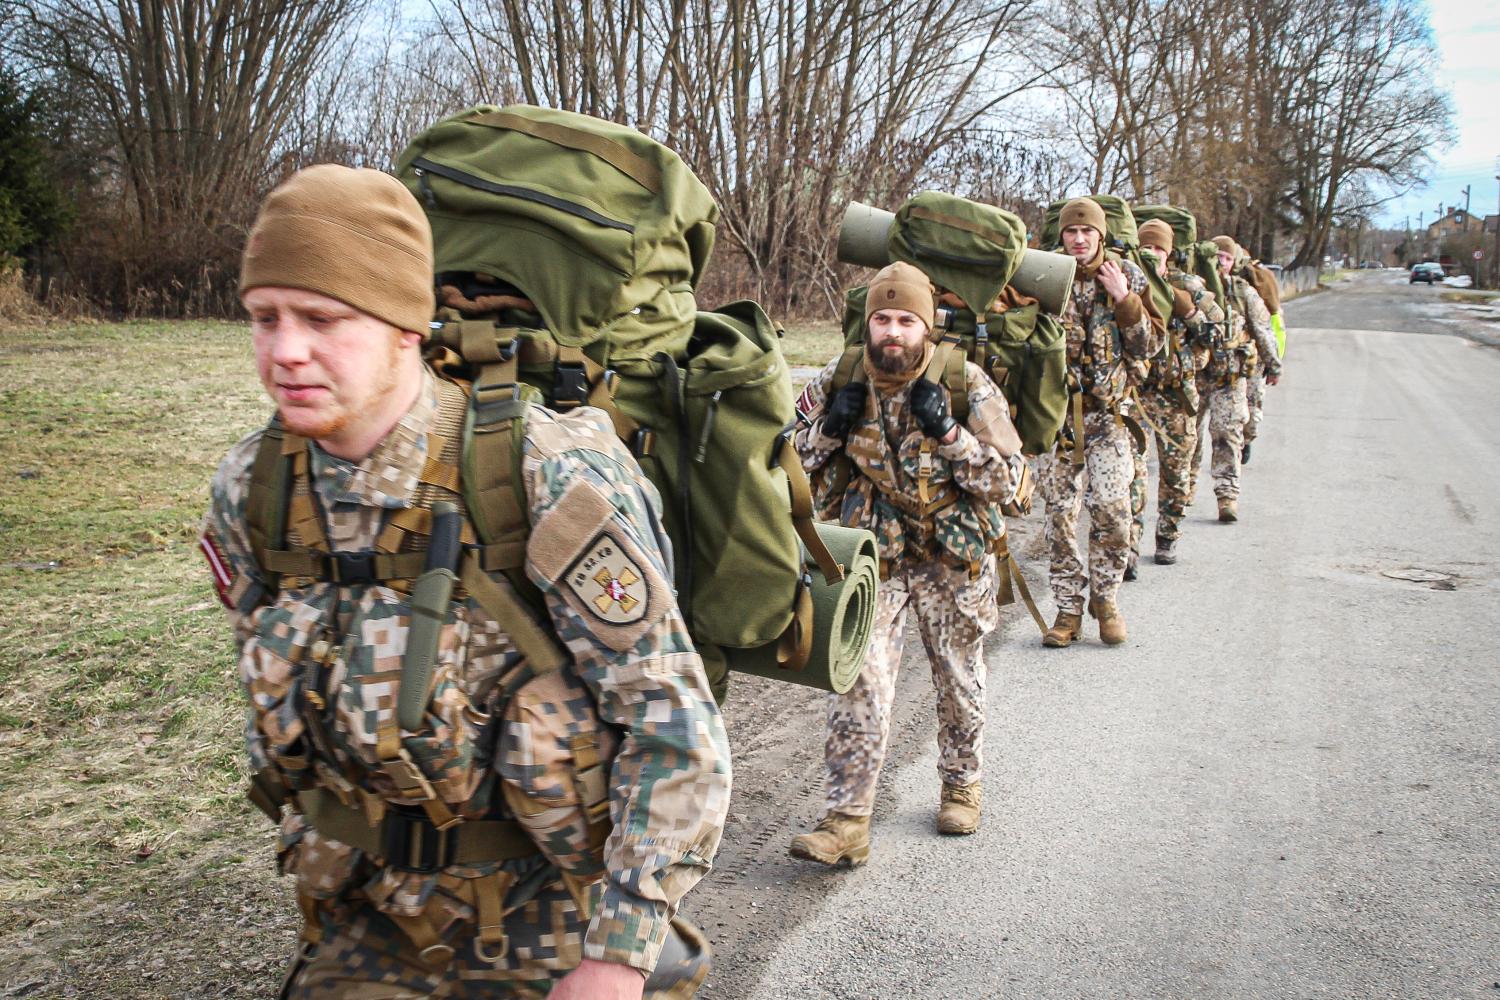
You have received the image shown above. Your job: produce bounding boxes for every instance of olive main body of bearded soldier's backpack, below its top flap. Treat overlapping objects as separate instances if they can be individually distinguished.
[843,286,1068,454]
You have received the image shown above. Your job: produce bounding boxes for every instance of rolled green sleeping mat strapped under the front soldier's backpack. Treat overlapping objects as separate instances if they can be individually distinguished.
[723,523,881,694]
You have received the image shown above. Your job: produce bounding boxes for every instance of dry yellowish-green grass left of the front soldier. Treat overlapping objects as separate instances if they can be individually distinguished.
[0,322,266,930]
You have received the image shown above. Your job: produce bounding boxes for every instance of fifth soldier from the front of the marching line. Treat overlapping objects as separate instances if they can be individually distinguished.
[1188,235,1281,525]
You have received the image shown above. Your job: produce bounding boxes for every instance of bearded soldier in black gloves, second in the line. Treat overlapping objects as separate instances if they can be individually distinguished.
[791,264,1022,865]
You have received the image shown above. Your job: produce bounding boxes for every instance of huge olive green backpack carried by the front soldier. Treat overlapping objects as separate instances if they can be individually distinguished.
[398,105,876,695]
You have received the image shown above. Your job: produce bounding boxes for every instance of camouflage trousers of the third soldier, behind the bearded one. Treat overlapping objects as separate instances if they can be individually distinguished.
[1038,412,1136,615]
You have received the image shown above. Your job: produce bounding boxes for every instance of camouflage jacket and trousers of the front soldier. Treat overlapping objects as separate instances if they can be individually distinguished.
[204,373,729,997]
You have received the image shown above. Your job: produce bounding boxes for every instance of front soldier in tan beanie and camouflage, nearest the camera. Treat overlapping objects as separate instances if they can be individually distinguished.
[203,165,729,1000]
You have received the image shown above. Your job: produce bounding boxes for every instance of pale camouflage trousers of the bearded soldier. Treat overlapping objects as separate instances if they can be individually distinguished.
[824,556,999,816]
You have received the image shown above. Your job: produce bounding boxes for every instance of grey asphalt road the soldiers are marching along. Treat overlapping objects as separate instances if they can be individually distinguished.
[690,271,1500,1000]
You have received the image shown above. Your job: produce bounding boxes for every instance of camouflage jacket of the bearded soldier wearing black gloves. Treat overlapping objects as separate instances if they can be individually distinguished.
[797,358,1020,573]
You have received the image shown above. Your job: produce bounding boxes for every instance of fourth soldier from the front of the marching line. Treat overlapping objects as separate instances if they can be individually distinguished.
[1133,219,1224,565]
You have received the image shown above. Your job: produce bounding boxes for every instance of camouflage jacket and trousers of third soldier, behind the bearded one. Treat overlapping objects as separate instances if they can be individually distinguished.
[1038,254,1163,615]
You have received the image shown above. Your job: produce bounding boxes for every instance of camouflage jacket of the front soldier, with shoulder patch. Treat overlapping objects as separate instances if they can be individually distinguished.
[204,373,731,970]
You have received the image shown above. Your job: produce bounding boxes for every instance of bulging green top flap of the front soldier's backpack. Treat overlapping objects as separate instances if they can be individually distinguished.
[398,105,719,358]
